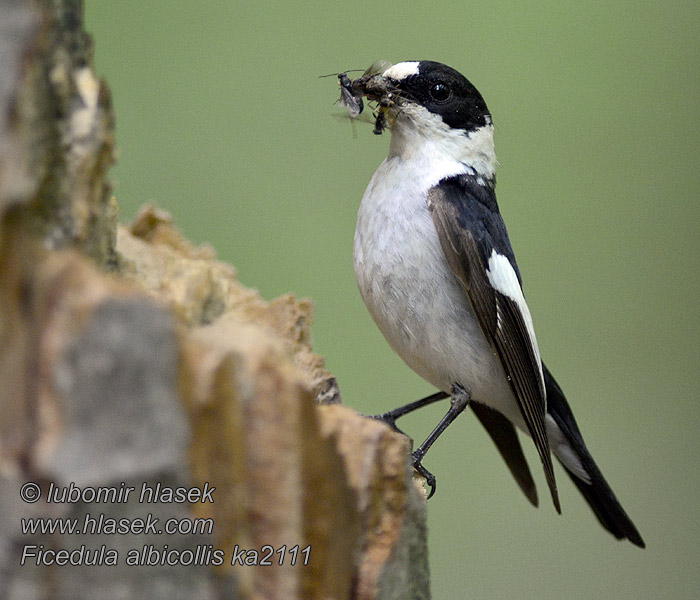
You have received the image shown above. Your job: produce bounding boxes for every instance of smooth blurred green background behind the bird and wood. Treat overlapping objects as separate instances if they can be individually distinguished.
[86,0,700,599]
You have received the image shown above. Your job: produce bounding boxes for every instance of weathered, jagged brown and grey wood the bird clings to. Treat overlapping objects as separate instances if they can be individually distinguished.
[0,0,429,600]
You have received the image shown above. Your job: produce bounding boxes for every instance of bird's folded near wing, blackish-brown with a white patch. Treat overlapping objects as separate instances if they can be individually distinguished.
[428,175,561,512]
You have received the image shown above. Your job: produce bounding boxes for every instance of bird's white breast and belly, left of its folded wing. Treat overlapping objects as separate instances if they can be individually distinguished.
[354,157,524,428]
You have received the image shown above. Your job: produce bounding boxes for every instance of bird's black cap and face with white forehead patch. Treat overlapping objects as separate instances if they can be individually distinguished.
[382,60,491,131]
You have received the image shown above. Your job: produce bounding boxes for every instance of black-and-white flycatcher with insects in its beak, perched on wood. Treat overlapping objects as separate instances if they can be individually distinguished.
[342,61,645,548]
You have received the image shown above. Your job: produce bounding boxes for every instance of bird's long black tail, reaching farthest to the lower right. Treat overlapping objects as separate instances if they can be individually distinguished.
[542,364,645,548]
